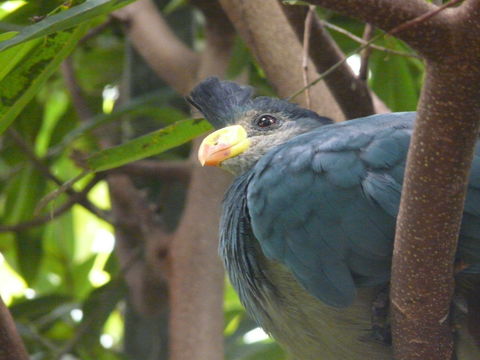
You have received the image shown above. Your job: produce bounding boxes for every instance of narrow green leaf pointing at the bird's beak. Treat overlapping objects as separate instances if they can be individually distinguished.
[87,119,212,171]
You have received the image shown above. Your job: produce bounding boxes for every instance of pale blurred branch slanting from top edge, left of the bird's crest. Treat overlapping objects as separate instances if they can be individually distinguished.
[113,0,198,94]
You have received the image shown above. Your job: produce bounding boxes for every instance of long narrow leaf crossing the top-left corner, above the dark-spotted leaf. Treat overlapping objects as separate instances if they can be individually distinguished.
[0,0,135,51]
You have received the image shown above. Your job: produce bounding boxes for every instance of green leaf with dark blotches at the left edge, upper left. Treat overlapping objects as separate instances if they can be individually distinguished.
[0,24,89,134]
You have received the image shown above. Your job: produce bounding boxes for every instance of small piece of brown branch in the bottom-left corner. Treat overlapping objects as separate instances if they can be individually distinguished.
[0,298,29,360]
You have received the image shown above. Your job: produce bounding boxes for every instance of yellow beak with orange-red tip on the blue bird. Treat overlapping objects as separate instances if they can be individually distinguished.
[198,125,250,166]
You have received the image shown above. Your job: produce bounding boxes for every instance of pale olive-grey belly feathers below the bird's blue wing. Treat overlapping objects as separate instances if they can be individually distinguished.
[253,260,392,360]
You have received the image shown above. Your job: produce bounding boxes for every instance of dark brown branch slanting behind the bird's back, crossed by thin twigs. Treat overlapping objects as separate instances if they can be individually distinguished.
[282,5,374,119]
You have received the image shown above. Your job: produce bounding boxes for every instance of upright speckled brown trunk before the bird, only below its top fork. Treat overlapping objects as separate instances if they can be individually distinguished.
[391,64,480,359]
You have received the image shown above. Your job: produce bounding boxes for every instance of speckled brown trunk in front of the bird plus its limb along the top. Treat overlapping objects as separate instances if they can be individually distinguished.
[309,0,480,359]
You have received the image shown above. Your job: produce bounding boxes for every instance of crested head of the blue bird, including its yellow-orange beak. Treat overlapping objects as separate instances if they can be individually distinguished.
[187,78,332,175]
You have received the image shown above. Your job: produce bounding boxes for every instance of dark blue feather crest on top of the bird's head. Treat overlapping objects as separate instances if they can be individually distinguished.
[186,77,253,129]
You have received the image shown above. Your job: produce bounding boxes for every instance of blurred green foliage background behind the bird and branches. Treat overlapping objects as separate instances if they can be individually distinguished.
[0,0,423,360]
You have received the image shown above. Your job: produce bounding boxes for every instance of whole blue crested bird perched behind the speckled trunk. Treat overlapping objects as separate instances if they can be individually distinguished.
[187,78,480,360]
